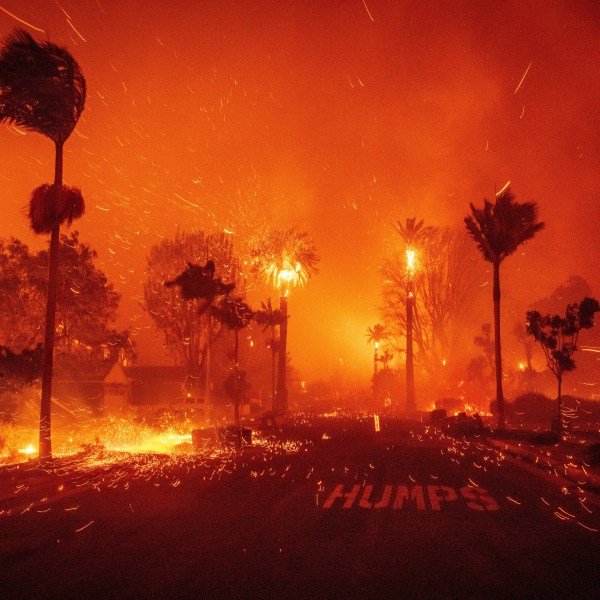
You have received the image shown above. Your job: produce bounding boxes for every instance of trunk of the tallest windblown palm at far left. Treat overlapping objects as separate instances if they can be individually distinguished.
[39,143,63,462]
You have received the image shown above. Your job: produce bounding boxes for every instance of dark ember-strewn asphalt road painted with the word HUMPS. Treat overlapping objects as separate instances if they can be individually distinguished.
[0,418,600,599]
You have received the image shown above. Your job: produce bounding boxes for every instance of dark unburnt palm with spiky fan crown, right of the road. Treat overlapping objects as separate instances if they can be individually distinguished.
[465,188,544,429]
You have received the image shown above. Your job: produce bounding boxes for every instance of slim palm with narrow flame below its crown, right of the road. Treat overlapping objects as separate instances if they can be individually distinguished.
[396,218,433,413]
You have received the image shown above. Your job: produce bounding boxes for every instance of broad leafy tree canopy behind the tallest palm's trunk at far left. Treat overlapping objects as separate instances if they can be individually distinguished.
[0,231,133,377]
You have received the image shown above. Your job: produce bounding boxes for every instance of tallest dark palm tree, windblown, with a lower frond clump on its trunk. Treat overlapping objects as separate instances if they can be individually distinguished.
[0,29,86,461]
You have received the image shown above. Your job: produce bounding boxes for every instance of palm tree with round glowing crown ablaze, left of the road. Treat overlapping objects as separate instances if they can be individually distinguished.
[252,228,319,412]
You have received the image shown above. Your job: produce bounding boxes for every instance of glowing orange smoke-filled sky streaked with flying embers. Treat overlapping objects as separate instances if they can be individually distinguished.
[0,0,600,377]
